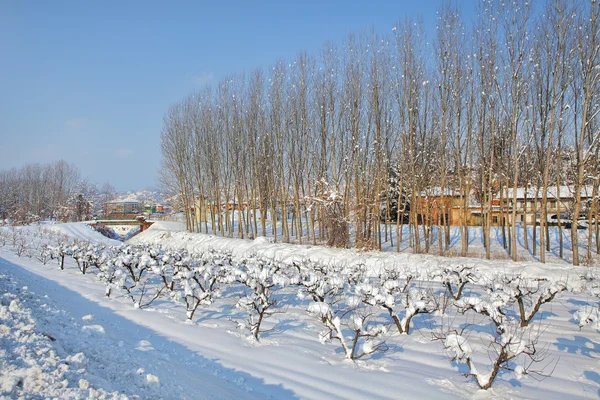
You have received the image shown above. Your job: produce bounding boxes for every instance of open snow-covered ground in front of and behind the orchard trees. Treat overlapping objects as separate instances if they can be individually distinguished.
[0,223,600,399]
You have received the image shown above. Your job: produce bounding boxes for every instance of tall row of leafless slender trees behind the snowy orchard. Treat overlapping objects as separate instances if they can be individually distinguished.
[162,0,600,264]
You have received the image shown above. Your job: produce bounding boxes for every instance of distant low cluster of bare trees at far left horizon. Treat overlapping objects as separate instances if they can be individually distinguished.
[0,161,95,224]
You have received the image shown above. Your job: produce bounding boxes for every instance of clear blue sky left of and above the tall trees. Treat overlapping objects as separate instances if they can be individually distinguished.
[0,0,474,190]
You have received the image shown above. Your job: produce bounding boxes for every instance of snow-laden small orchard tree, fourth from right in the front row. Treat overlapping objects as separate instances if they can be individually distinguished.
[171,251,234,322]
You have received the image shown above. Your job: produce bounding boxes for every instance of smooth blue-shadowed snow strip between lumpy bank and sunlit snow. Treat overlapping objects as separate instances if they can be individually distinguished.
[0,258,294,399]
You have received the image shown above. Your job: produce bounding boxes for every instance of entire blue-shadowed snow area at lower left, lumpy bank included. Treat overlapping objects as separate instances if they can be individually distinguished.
[0,259,290,399]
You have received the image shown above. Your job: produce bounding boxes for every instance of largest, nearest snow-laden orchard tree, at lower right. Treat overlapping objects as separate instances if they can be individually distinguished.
[434,276,558,389]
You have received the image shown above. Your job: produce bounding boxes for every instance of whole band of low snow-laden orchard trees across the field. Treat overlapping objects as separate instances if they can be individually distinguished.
[0,228,600,389]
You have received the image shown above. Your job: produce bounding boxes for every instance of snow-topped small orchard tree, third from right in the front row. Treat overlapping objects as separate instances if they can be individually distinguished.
[230,255,299,340]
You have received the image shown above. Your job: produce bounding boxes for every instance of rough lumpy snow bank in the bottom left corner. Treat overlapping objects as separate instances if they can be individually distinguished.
[0,274,125,398]
